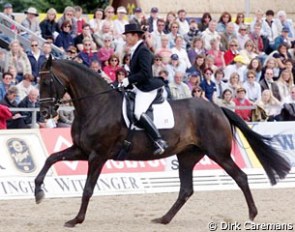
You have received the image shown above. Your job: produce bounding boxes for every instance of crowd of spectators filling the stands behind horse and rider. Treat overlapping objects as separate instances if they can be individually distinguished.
[0,3,295,128]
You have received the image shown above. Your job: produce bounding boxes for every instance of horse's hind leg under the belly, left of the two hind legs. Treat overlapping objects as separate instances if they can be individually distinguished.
[152,151,204,224]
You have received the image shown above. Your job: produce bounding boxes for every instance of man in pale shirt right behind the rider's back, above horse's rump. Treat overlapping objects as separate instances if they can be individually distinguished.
[169,72,192,100]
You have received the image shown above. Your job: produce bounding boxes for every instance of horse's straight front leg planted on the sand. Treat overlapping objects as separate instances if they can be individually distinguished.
[65,152,106,227]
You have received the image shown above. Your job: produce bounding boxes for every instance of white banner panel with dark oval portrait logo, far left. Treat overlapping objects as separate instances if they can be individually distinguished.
[0,129,51,177]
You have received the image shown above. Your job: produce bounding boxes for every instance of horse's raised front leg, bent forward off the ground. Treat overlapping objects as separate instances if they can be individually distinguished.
[35,145,88,204]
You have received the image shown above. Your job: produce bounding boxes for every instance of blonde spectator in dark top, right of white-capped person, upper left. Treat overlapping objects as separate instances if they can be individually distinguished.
[40,8,59,40]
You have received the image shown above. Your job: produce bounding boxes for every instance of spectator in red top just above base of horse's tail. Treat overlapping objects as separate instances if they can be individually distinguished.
[233,87,252,122]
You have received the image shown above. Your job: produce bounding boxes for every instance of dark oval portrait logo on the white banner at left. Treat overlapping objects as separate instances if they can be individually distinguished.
[6,138,36,173]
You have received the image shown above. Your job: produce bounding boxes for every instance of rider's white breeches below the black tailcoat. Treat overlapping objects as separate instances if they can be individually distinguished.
[132,86,158,120]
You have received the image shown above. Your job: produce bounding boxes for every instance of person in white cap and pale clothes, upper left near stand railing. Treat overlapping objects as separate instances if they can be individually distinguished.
[21,7,41,38]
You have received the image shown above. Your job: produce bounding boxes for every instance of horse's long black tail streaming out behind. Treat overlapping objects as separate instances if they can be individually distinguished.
[221,107,291,185]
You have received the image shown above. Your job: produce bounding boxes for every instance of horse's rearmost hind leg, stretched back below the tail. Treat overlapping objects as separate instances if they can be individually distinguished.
[212,153,257,220]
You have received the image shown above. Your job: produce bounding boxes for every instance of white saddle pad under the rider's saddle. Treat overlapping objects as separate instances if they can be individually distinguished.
[122,98,175,130]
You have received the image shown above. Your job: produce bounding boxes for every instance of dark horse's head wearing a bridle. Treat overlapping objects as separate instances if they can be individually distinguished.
[39,56,67,119]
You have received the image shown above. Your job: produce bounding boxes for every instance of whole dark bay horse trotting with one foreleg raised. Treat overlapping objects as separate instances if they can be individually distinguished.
[35,58,290,227]
